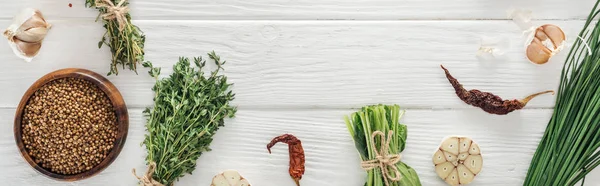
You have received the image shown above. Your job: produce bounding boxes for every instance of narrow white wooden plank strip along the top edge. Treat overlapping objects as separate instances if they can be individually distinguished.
[0,0,595,20]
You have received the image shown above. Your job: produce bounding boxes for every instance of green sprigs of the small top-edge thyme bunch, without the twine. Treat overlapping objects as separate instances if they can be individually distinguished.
[85,0,146,75]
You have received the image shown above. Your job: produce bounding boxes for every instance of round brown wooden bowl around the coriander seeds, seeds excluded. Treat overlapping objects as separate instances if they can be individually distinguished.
[14,68,129,181]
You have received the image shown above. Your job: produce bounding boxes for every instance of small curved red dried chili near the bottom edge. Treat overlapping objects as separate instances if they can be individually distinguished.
[267,134,305,186]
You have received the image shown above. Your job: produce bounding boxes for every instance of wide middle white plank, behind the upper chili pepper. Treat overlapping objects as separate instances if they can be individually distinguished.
[0,20,583,109]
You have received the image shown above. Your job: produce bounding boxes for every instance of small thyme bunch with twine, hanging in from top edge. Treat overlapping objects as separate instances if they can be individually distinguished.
[85,0,146,75]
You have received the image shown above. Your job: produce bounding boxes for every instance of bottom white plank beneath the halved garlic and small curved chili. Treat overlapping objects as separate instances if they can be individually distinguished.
[0,109,600,186]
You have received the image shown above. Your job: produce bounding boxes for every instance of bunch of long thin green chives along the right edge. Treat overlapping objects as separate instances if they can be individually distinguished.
[523,1,600,186]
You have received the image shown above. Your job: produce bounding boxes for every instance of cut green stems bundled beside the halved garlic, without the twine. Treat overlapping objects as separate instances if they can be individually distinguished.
[344,105,421,186]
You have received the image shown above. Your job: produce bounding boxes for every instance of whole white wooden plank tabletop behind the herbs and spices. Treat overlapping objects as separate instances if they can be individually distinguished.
[0,0,600,186]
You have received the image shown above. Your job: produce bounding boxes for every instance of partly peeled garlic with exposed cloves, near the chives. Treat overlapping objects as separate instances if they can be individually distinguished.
[526,24,566,64]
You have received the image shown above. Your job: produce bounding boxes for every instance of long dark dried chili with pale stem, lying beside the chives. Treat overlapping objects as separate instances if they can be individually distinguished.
[440,65,554,115]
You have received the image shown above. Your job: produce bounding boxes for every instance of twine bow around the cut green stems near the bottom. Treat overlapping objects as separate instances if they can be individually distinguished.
[361,130,402,186]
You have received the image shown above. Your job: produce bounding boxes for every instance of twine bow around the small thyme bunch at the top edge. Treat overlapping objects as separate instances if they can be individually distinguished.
[95,0,129,31]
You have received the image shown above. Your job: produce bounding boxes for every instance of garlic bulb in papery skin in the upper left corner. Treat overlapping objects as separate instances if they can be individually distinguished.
[4,8,51,62]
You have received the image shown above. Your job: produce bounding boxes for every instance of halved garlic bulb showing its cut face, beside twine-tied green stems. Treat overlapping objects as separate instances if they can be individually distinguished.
[433,136,483,185]
